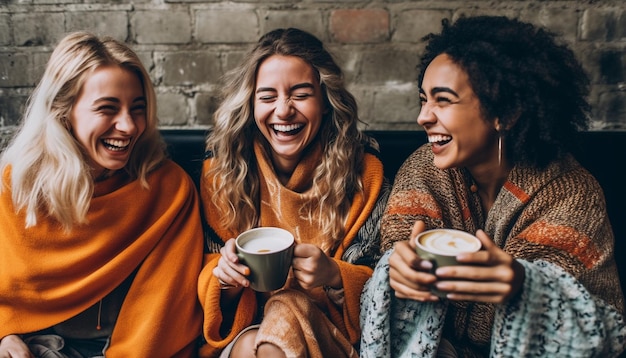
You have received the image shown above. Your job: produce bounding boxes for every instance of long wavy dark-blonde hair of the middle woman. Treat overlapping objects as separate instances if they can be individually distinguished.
[206,28,367,248]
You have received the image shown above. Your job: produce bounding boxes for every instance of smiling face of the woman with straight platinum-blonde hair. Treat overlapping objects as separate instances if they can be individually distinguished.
[70,66,146,178]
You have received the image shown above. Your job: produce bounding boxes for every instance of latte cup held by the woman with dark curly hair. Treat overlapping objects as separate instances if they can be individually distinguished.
[415,229,482,297]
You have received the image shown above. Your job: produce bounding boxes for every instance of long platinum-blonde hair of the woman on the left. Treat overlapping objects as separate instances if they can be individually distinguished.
[0,32,166,230]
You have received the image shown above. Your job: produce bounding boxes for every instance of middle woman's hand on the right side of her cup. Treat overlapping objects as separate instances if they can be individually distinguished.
[291,244,343,290]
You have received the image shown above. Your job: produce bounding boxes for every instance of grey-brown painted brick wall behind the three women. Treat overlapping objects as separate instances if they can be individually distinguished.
[0,0,626,133]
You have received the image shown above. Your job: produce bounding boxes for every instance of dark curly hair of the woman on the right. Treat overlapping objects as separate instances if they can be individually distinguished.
[418,16,590,167]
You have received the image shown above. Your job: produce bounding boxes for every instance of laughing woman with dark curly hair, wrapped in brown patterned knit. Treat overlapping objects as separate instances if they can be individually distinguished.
[361,16,626,358]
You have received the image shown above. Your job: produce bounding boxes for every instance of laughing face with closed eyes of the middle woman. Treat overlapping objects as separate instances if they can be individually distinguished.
[254,55,324,175]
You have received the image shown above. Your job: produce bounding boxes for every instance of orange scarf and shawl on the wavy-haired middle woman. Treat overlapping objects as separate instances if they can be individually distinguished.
[198,144,383,356]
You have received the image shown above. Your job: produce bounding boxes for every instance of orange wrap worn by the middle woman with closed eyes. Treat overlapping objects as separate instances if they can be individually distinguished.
[199,144,388,357]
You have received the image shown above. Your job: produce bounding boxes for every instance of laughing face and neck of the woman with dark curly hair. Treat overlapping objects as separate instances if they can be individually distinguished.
[417,54,498,171]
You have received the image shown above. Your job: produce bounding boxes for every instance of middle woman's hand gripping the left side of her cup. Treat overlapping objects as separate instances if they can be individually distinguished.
[213,239,250,291]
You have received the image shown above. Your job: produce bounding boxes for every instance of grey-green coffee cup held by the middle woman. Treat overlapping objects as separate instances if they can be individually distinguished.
[235,227,295,292]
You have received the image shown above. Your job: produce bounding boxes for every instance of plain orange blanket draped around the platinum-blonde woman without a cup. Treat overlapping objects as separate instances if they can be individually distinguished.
[0,161,203,357]
